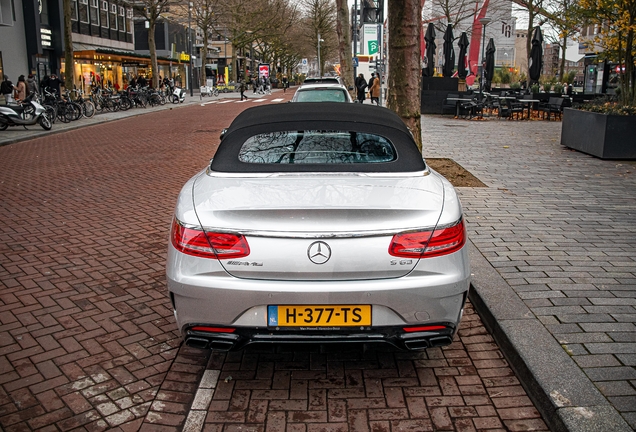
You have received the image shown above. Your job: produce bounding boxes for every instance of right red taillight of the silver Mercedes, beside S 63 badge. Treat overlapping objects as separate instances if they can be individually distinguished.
[389,219,466,258]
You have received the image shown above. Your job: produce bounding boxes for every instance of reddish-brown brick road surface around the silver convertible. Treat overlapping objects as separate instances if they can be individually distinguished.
[0,94,546,431]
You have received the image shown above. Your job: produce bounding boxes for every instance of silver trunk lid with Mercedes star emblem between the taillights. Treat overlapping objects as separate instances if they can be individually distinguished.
[193,174,444,281]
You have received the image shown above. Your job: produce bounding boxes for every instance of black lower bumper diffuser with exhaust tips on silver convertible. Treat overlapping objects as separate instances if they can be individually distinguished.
[183,323,457,351]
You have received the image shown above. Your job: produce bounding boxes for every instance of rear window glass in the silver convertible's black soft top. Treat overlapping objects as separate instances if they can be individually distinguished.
[238,130,397,165]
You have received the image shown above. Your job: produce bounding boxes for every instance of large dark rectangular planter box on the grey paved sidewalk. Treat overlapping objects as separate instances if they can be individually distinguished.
[561,108,636,160]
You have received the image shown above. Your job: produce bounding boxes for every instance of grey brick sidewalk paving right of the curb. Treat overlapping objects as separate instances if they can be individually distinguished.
[422,116,636,430]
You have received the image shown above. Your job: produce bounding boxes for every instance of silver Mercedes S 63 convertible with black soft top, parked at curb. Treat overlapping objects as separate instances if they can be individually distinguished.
[166,102,470,350]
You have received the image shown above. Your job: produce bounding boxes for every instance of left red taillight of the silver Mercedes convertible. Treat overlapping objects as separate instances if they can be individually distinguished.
[170,218,250,259]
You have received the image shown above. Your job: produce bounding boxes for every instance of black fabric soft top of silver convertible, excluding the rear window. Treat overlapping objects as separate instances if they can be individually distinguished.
[211,102,426,173]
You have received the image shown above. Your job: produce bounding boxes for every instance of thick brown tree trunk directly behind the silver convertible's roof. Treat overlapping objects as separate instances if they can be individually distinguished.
[387,0,422,150]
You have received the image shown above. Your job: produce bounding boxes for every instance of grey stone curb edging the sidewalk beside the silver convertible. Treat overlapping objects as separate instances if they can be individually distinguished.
[469,242,633,432]
